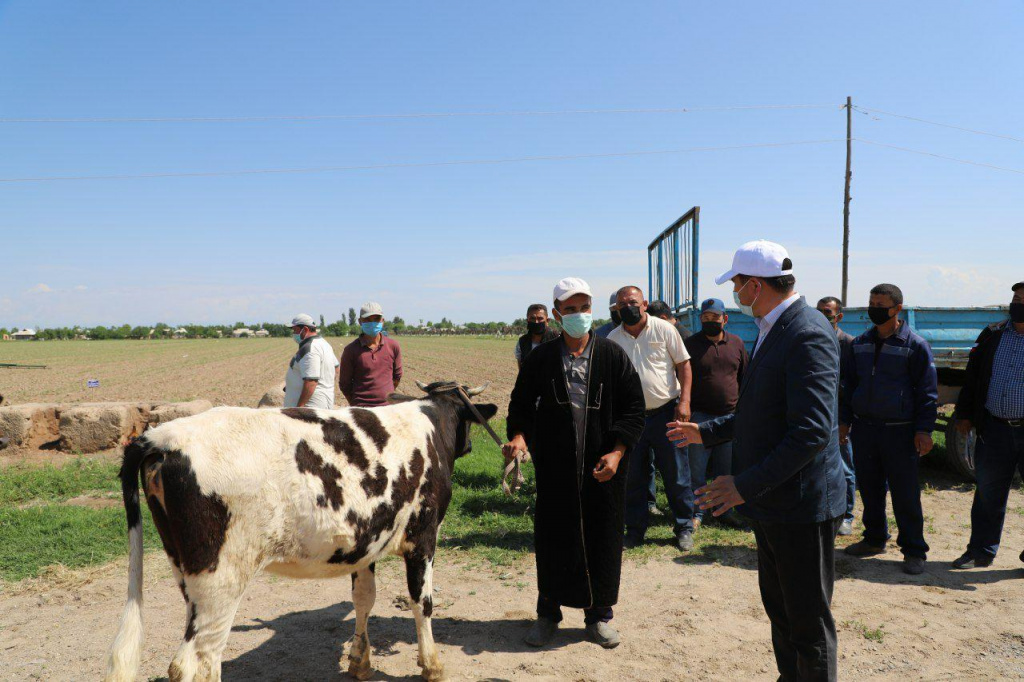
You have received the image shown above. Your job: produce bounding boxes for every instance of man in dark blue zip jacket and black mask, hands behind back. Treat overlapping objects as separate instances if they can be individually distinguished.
[840,284,939,576]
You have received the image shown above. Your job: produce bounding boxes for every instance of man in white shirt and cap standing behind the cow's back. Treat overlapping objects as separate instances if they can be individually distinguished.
[284,313,339,410]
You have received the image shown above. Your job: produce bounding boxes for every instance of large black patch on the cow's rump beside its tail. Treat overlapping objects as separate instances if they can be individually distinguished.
[146,451,231,574]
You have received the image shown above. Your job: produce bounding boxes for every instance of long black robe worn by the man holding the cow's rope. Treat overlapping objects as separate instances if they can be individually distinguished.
[508,333,644,608]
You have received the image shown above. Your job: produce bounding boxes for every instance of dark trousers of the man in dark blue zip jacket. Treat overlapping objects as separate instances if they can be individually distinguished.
[850,421,928,559]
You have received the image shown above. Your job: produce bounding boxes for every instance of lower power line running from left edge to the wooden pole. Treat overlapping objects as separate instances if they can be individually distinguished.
[0,138,846,182]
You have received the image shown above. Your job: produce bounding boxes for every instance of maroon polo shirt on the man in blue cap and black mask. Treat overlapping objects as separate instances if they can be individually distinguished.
[683,332,749,416]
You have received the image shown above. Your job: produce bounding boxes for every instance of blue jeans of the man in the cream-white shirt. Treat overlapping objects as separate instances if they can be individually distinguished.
[626,400,693,538]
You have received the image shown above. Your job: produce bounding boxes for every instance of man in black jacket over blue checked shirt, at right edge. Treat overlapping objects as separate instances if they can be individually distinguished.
[953,282,1024,568]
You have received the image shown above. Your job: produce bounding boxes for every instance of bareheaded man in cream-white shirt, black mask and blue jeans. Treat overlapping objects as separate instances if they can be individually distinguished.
[608,287,693,552]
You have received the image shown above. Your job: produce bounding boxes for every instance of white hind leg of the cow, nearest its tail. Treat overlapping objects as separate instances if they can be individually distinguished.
[167,562,255,682]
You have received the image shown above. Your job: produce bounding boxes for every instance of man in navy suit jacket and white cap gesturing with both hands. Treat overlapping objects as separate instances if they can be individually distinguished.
[669,241,846,680]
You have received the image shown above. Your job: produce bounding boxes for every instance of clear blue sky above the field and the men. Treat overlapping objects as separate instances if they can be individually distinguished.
[0,0,1024,327]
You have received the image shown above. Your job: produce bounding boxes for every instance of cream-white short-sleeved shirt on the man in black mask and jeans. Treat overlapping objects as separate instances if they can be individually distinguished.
[608,315,690,410]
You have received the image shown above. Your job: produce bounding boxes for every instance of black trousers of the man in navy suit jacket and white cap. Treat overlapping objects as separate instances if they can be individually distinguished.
[753,517,843,682]
